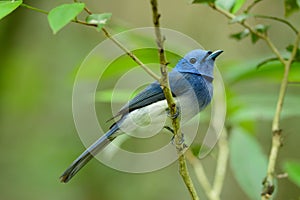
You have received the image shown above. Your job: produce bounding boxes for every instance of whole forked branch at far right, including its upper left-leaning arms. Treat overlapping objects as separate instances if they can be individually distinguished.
[205,1,300,200]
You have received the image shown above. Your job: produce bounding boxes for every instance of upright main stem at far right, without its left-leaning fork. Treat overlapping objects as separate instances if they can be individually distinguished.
[261,33,300,200]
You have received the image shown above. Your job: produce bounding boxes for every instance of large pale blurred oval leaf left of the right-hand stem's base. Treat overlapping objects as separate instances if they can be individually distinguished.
[230,128,267,200]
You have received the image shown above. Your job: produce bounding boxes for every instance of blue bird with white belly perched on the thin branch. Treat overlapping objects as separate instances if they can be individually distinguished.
[60,49,223,183]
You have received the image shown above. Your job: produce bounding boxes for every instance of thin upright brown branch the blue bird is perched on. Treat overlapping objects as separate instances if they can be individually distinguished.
[151,0,199,200]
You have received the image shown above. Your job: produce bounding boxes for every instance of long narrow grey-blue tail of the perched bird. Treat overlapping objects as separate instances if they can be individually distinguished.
[60,125,118,183]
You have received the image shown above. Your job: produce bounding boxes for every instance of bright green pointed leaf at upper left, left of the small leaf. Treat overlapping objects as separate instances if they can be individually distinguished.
[48,3,85,34]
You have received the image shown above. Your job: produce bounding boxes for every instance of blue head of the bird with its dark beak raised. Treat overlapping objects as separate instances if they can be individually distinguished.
[175,49,223,79]
